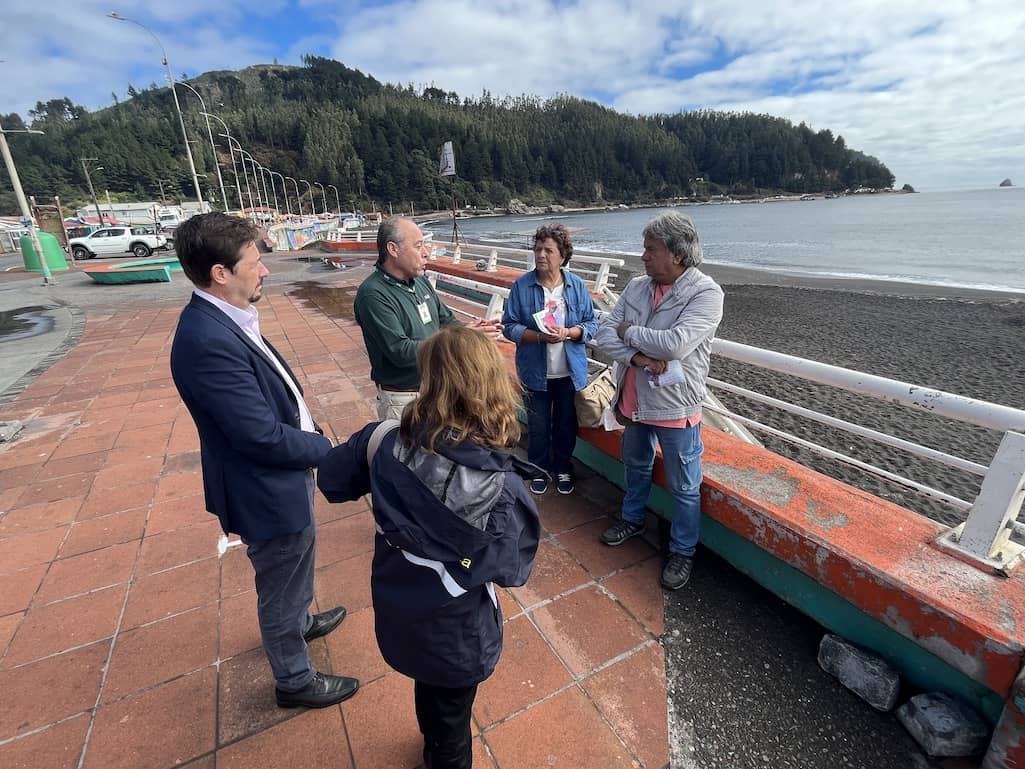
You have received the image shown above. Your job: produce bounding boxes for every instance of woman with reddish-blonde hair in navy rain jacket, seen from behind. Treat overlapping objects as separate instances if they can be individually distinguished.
[318,326,540,769]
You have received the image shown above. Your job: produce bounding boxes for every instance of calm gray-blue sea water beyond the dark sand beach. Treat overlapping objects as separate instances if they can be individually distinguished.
[420,188,1025,293]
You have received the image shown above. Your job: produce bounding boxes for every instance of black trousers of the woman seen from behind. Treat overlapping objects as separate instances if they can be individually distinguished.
[413,681,477,769]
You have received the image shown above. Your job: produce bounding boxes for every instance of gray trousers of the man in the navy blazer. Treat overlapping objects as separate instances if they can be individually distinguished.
[246,473,317,691]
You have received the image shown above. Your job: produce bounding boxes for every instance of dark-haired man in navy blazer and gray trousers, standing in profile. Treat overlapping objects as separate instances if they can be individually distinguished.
[171,213,360,707]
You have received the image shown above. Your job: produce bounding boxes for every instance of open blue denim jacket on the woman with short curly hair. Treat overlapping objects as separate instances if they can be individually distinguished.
[502,270,598,390]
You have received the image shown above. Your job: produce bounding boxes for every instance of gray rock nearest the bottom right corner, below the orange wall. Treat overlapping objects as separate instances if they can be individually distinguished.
[897,692,989,758]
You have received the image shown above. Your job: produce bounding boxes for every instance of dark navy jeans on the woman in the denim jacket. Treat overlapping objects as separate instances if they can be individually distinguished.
[524,376,577,475]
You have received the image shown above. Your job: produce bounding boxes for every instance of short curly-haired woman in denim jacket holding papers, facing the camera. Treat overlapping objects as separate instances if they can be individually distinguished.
[502,225,598,494]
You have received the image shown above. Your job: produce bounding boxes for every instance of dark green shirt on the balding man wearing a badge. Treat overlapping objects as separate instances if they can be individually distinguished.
[355,266,461,390]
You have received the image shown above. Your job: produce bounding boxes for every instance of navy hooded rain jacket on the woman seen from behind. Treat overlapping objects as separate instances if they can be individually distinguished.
[318,422,540,688]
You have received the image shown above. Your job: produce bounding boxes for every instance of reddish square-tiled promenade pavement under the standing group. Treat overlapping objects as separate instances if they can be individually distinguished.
[0,281,668,769]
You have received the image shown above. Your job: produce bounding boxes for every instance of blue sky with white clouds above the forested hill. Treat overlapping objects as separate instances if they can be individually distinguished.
[0,0,1025,191]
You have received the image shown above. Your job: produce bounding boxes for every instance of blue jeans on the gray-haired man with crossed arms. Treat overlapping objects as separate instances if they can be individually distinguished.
[622,422,704,556]
